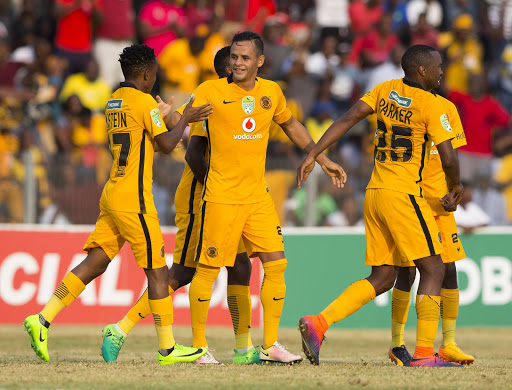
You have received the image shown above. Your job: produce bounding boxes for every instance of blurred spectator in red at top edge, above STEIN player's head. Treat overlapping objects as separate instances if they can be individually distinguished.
[139,0,187,57]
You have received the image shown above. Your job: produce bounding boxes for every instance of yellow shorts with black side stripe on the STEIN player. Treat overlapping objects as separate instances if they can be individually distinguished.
[84,205,166,269]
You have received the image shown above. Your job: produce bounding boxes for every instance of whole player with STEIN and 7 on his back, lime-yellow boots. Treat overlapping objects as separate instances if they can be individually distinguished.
[23,45,211,364]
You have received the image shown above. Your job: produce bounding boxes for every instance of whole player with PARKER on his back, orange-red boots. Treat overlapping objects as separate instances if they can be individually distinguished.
[297,45,463,367]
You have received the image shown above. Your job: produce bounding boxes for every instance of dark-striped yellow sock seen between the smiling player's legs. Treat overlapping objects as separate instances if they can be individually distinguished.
[227,285,252,349]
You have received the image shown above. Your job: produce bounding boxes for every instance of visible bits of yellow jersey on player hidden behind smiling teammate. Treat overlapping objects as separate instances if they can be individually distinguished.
[174,121,208,214]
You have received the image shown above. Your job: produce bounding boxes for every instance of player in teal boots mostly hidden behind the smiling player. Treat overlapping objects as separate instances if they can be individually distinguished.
[101,46,259,364]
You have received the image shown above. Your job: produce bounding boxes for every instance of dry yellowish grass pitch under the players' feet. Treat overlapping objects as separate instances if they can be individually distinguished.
[0,324,512,390]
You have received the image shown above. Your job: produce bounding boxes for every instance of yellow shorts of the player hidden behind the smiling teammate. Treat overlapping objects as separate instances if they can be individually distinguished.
[173,213,245,268]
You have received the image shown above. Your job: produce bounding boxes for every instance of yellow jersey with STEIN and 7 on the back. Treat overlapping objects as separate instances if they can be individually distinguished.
[100,82,167,213]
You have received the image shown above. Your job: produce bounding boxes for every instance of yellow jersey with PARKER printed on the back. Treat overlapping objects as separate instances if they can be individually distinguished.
[361,79,455,196]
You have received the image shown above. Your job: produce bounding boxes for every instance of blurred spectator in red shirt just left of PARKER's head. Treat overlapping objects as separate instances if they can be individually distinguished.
[349,13,399,68]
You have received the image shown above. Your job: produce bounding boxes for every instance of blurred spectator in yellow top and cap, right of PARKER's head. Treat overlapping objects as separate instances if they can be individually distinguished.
[439,14,483,93]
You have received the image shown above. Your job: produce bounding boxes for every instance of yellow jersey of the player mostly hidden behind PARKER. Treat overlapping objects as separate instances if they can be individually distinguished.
[421,95,466,215]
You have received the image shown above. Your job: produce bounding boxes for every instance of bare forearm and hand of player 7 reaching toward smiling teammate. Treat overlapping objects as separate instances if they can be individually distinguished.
[155,96,213,153]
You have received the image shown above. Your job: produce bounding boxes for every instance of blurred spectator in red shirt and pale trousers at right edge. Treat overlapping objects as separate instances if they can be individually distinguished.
[448,74,510,180]
